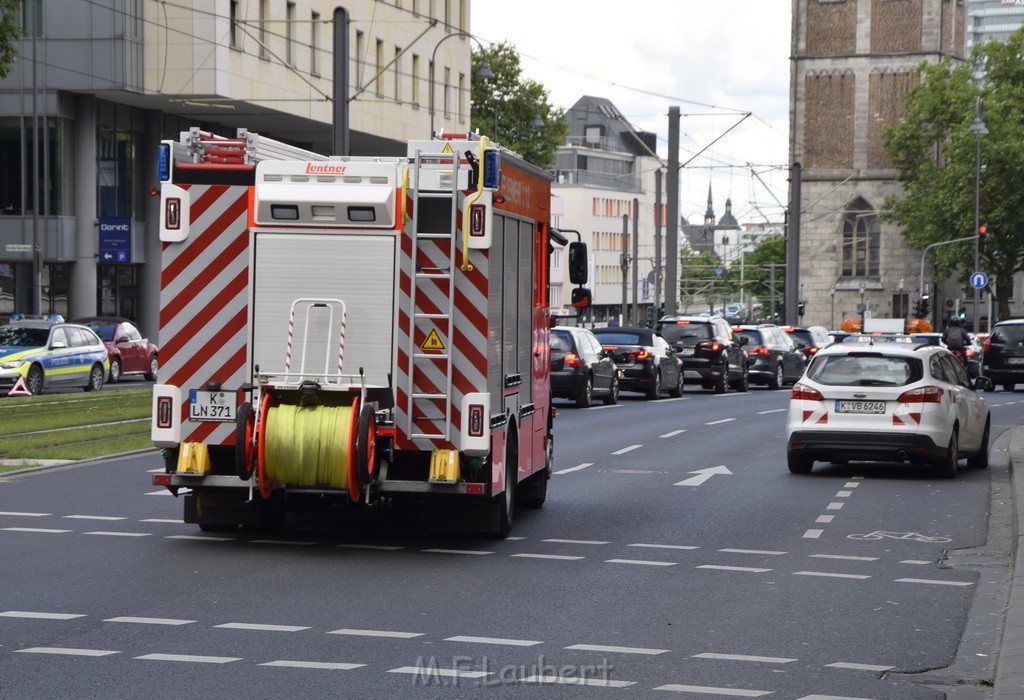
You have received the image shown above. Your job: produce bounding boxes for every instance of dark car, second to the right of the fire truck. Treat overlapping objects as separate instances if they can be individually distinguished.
[594,327,683,399]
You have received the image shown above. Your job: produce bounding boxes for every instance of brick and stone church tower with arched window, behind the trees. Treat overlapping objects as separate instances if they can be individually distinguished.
[790,0,966,327]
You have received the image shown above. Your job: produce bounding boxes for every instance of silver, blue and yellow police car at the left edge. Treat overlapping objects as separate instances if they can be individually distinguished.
[0,314,110,394]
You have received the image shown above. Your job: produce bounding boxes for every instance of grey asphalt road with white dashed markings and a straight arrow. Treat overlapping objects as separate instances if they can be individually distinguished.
[0,389,1024,700]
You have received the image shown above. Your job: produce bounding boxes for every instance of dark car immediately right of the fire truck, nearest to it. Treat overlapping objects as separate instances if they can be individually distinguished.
[551,326,618,408]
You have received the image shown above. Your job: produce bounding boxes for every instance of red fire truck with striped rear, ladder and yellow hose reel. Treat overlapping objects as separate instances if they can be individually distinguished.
[152,129,586,536]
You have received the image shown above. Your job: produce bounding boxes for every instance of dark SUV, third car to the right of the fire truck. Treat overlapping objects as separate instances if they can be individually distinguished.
[654,316,750,394]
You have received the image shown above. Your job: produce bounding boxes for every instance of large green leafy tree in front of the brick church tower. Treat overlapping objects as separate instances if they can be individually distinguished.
[883,28,1024,318]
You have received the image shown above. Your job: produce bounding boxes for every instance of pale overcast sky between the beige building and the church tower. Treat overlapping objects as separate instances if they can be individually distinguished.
[470,0,792,223]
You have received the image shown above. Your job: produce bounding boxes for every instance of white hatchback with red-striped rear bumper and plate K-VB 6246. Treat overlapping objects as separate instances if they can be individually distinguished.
[786,342,991,478]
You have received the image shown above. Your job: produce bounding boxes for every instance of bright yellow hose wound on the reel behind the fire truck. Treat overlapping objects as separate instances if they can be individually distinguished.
[264,403,355,489]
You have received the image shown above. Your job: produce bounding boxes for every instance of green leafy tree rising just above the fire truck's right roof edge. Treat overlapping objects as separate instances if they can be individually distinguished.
[470,43,569,168]
